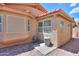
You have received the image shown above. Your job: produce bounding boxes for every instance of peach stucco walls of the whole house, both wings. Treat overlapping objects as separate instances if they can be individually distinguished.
[0,5,72,48]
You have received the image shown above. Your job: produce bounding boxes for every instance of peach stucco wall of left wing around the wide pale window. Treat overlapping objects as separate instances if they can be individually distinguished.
[0,11,37,47]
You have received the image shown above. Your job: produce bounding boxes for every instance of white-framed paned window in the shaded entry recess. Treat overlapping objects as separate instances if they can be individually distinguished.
[38,20,52,33]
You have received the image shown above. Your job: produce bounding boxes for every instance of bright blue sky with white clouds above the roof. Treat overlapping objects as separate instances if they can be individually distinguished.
[41,3,79,22]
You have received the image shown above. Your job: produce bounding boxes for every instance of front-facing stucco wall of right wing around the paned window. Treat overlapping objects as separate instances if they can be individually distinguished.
[38,15,57,47]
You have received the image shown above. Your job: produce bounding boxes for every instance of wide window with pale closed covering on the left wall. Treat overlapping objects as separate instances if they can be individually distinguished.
[6,15,26,33]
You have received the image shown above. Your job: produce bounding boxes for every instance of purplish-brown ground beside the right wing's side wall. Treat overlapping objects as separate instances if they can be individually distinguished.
[60,38,79,54]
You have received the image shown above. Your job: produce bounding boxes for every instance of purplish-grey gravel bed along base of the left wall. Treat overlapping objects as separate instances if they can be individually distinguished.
[0,43,38,56]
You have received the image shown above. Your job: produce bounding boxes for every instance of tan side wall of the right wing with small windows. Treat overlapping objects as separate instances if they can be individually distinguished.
[56,17,72,47]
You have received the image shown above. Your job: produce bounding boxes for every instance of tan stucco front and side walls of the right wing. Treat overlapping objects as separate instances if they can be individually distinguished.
[38,14,72,47]
